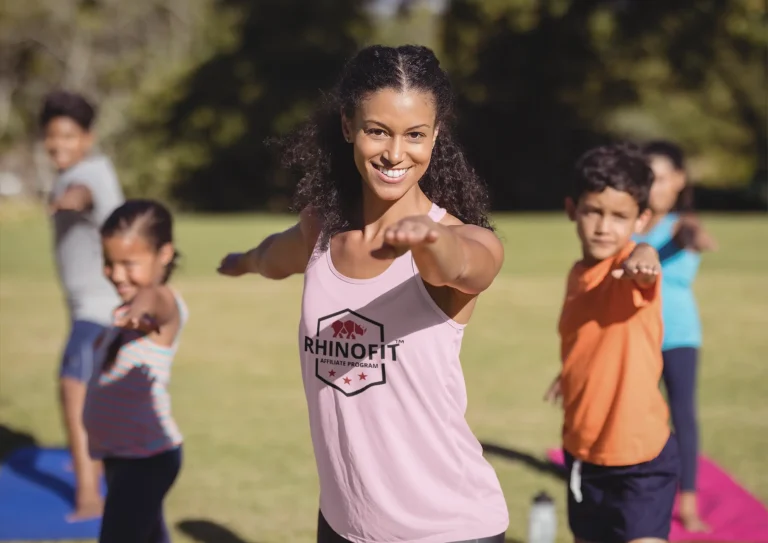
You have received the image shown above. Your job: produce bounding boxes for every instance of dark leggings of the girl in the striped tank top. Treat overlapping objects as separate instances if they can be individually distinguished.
[99,448,181,543]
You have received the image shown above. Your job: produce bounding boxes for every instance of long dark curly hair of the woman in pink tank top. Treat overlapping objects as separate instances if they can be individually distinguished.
[280,45,493,248]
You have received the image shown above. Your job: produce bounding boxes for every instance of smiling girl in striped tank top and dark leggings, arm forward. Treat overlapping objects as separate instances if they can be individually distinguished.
[85,200,187,543]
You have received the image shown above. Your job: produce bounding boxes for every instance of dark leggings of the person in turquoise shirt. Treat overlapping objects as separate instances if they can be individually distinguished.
[662,347,699,492]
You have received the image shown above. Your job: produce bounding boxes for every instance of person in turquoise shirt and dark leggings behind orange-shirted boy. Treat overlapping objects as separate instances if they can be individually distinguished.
[635,141,716,532]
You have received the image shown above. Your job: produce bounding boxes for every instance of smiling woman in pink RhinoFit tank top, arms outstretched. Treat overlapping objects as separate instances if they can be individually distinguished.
[219,46,508,543]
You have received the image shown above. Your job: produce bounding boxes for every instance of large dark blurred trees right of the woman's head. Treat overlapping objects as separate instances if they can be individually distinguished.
[443,0,766,209]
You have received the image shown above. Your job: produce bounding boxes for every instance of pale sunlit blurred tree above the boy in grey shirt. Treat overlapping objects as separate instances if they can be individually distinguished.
[0,0,218,193]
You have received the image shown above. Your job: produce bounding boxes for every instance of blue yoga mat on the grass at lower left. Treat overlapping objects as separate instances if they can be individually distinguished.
[0,446,106,541]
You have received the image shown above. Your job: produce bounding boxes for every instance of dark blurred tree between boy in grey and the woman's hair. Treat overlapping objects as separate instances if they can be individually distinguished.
[123,0,369,211]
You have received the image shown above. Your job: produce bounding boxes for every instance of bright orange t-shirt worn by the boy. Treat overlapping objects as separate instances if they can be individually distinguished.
[559,243,670,466]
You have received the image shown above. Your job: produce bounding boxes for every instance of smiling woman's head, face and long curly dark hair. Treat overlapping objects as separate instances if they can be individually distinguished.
[281,46,491,250]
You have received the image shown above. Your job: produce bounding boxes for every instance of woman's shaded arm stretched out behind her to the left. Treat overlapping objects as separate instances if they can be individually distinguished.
[217,209,320,279]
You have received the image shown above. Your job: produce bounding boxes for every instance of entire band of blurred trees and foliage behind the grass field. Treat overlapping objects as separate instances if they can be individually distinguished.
[0,0,768,211]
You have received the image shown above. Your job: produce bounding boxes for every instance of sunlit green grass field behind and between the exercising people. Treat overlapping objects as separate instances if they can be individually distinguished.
[0,209,768,543]
